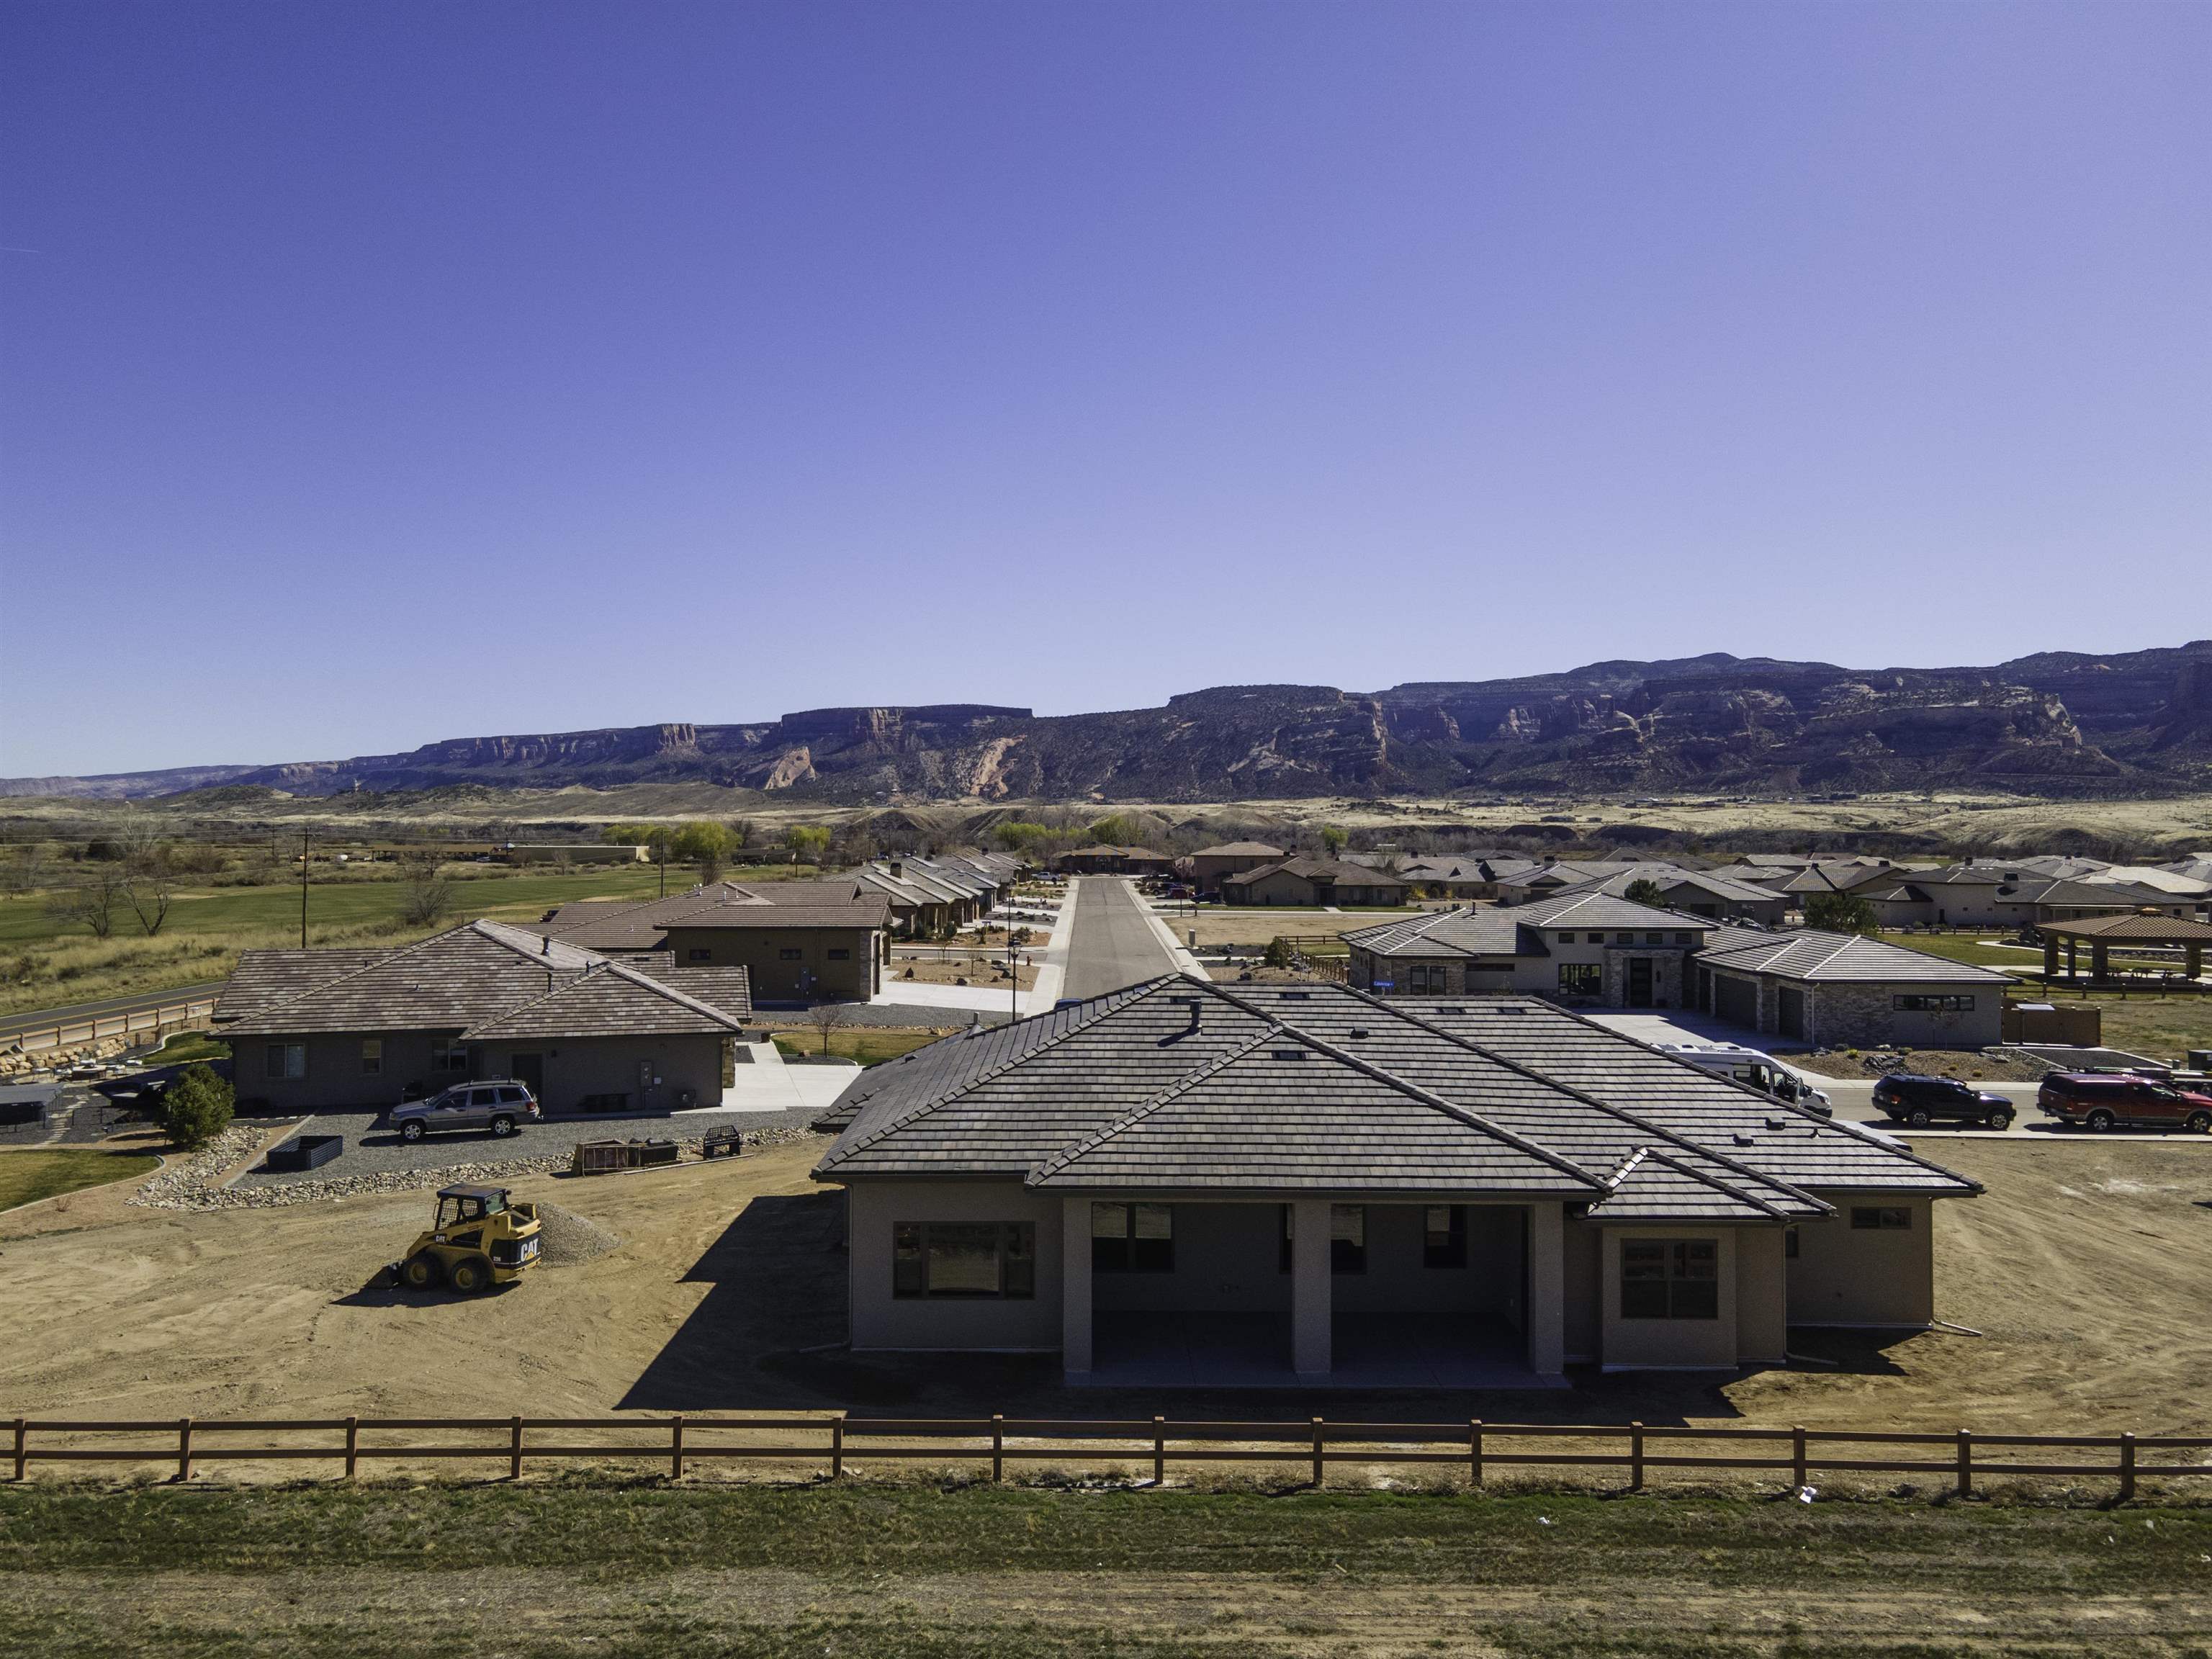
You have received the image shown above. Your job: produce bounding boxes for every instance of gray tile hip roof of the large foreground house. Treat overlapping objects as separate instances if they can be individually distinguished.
[817,978,1975,1221]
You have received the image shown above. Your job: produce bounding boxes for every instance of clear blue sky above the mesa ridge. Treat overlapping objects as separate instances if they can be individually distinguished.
[0,0,2212,774]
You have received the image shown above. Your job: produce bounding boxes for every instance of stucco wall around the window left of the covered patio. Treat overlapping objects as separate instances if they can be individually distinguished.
[845,1181,1062,1352]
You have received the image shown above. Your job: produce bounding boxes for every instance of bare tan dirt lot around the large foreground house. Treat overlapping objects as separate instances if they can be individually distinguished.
[0,1139,2212,1434]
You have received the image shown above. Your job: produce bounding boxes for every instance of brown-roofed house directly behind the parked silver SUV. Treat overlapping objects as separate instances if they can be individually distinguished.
[215,922,752,1112]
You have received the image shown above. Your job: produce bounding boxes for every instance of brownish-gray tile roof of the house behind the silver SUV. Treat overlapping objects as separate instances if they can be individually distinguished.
[217,922,750,1038]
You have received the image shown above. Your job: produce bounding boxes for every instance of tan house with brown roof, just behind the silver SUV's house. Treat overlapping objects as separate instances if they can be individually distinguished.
[533,878,891,1002]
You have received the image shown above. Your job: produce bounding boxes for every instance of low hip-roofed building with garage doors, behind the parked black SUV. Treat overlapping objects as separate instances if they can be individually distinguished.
[1692,929,2013,1048]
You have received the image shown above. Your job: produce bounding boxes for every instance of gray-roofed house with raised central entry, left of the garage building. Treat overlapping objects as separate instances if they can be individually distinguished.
[1345,894,1717,1009]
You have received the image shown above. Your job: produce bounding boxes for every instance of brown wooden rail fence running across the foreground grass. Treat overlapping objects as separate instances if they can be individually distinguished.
[11,1413,2212,1500]
